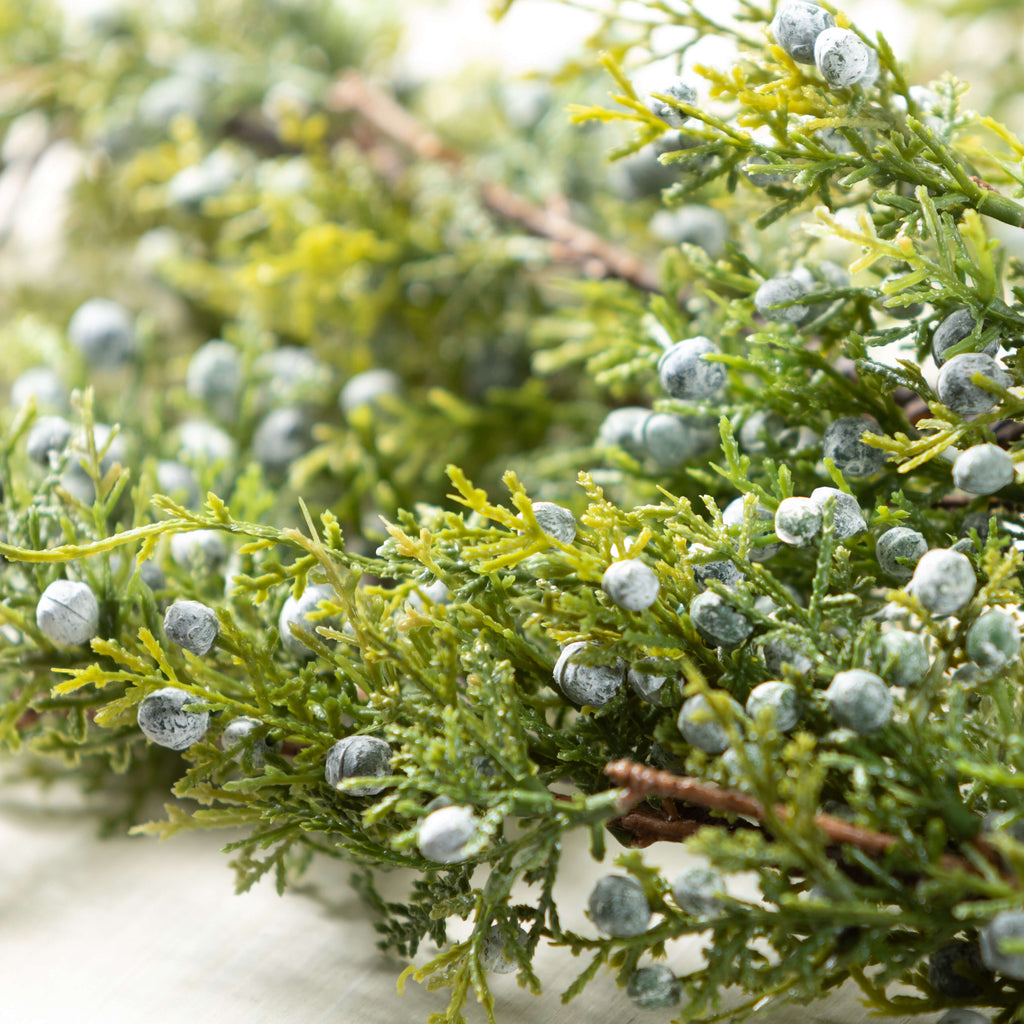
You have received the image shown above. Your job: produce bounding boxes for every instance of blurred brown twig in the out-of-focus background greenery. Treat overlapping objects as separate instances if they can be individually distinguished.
[326,71,660,292]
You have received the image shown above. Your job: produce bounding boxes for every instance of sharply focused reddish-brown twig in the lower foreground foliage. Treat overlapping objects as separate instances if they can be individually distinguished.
[604,759,1015,881]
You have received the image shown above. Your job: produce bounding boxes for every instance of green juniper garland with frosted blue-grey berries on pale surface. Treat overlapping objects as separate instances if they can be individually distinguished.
[0,0,1024,1022]
